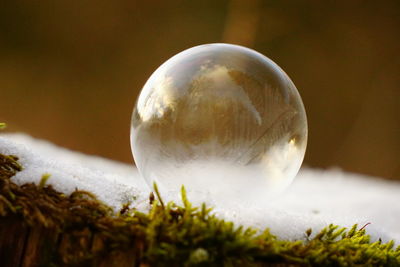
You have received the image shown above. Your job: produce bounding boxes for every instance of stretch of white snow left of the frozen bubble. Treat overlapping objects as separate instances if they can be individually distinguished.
[0,134,150,213]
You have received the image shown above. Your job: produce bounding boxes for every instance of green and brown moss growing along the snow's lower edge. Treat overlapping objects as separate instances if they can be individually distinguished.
[0,154,400,266]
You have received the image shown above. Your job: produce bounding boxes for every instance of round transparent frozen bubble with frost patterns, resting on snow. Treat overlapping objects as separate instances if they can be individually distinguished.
[131,44,307,206]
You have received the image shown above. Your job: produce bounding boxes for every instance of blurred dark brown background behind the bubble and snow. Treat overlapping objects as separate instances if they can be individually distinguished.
[0,0,400,179]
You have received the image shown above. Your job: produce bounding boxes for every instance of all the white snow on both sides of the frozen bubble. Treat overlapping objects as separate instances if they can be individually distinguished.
[0,134,400,243]
